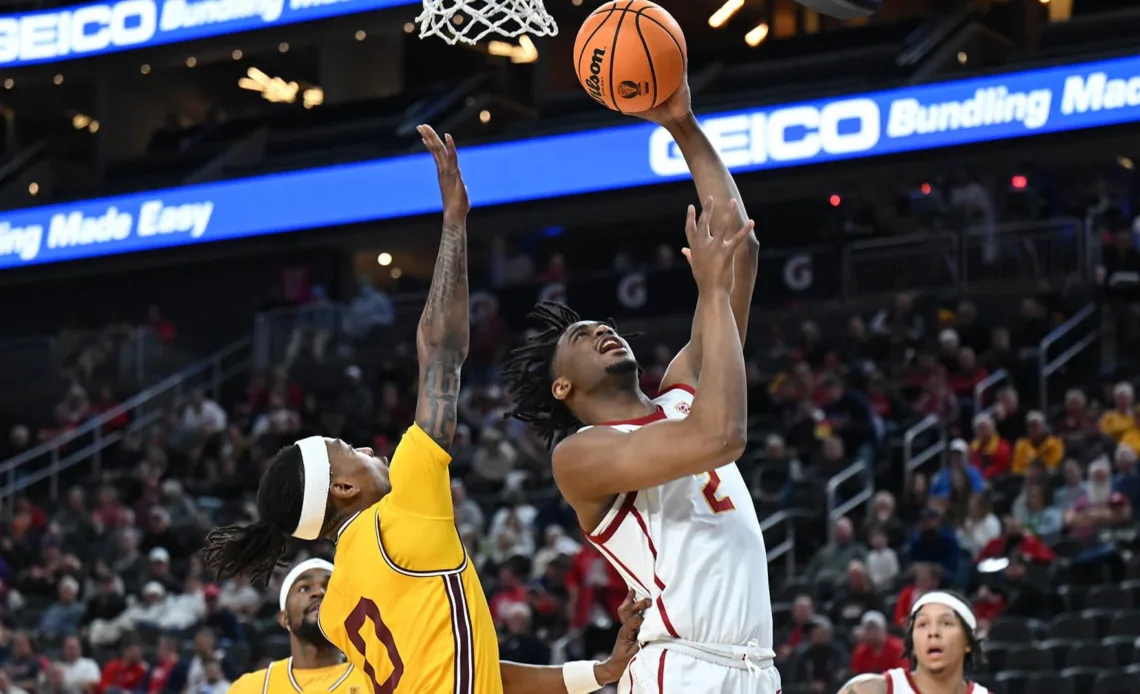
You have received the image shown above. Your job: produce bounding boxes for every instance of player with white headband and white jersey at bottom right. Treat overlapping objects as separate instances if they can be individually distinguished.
[839,590,990,694]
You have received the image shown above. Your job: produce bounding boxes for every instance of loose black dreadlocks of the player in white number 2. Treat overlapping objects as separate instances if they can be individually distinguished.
[502,301,581,447]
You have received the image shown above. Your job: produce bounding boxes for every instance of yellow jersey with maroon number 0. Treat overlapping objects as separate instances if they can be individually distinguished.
[318,424,503,694]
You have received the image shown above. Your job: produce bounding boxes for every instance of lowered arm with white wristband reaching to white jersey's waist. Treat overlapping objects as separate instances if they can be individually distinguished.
[499,590,653,694]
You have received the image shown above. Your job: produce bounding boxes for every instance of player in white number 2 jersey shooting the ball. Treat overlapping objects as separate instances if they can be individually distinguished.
[503,74,780,694]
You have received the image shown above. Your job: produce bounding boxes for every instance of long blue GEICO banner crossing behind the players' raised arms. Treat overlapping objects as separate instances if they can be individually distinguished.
[0,52,1140,268]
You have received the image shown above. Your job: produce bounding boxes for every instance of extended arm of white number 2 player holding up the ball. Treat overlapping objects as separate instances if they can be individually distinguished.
[637,74,760,389]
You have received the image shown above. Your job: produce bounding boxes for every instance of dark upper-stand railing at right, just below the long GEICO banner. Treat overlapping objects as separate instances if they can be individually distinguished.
[842,218,1096,297]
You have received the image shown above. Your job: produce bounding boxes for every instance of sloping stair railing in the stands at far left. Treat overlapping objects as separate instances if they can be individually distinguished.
[0,337,251,513]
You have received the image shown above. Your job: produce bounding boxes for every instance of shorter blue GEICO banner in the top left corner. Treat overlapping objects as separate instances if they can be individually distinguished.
[0,0,415,67]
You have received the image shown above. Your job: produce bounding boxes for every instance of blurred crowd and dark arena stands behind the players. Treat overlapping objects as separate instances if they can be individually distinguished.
[0,0,1140,694]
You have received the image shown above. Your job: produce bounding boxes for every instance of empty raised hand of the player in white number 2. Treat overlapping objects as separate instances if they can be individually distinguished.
[681,197,755,292]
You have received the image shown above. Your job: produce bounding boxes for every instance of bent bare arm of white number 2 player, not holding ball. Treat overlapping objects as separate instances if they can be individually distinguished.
[554,198,752,496]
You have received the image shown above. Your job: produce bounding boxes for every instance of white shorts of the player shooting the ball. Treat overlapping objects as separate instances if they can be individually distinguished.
[618,644,781,694]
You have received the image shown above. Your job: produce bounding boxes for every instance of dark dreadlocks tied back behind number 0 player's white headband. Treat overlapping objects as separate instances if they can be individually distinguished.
[202,444,333,587]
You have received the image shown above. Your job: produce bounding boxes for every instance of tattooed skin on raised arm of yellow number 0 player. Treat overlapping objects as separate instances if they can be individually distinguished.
[416,221,471,450]
